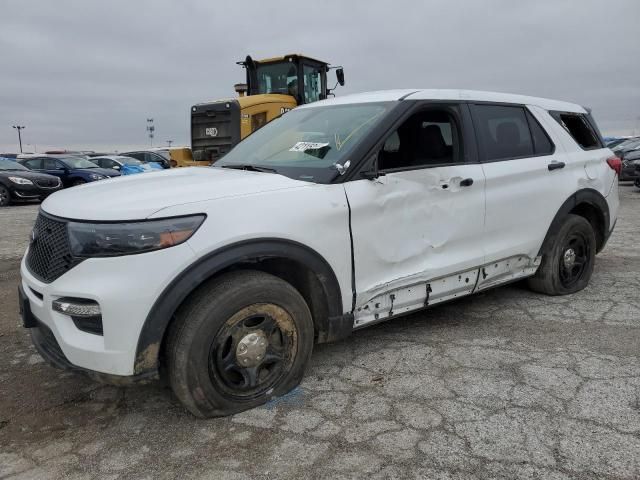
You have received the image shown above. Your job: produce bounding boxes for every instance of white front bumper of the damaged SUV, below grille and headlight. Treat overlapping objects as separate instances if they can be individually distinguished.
[20,243,194,384]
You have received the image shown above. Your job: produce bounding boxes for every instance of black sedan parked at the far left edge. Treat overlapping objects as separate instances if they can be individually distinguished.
[0,158,62,207]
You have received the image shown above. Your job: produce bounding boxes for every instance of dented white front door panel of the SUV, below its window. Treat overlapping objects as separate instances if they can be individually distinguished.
[345,164,484,310]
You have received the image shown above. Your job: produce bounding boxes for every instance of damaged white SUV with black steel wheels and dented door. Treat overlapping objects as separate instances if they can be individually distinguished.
[21,90,621,416]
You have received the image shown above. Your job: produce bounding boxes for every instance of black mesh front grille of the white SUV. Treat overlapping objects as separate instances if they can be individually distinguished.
[27,212,82,283]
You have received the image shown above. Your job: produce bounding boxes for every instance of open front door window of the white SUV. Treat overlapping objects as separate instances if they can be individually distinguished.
[379,108,464,170]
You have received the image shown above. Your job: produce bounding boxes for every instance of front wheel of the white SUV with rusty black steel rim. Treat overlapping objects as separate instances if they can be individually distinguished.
[165,270,314,417]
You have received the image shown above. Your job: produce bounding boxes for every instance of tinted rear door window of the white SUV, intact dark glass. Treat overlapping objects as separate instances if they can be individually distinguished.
[473,105,534,161]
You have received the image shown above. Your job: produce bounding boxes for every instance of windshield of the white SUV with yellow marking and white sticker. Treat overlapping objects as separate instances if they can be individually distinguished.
[214,102,396,183]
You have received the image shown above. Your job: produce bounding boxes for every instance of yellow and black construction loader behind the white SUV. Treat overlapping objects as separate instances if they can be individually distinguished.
[191,54,344,165]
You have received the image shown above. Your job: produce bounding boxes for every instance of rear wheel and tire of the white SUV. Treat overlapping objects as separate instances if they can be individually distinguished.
[528,214,596,295]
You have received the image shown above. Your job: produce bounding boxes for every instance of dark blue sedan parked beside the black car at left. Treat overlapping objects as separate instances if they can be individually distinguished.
[18,155,120,188]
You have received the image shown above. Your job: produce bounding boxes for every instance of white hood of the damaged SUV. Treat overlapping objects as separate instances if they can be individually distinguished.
[42,167,313,221]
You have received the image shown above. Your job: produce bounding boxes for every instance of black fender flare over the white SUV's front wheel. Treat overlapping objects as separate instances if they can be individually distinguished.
[134,238,353,375]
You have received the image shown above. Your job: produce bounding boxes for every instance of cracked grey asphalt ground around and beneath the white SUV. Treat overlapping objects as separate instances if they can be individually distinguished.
[0,186,640,480]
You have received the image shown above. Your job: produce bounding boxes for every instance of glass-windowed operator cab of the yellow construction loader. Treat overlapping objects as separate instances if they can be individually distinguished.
[238,54,329,105]
